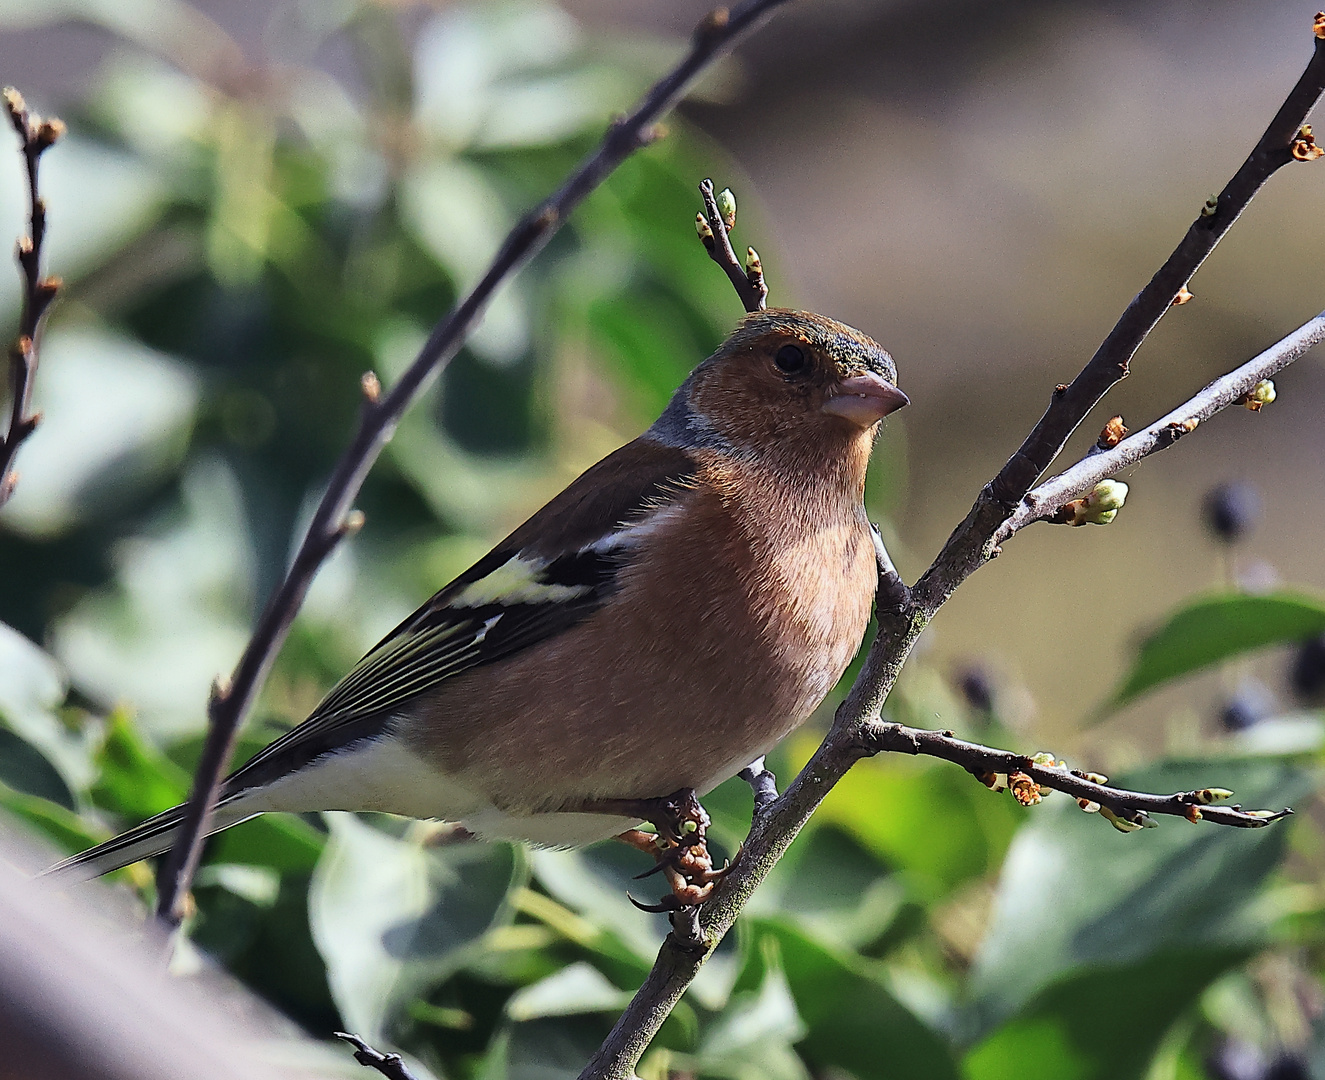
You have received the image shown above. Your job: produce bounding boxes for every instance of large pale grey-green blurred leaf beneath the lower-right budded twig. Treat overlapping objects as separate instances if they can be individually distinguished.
[969,759,1312,1034]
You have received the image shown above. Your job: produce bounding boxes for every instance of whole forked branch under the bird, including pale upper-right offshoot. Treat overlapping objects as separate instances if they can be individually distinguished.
[580,13,1325,1080]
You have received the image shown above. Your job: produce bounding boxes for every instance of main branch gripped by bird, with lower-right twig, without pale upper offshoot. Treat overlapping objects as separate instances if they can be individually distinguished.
[580,20,1325,1080]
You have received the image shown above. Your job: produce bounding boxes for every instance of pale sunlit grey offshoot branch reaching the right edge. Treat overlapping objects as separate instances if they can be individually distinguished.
[995,311,1325,543]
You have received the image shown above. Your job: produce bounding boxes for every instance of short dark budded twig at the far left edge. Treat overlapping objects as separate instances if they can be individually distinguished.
[0,86,65,506]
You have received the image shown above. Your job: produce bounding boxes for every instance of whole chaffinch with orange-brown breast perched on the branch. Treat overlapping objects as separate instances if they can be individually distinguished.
[53,309,908,901]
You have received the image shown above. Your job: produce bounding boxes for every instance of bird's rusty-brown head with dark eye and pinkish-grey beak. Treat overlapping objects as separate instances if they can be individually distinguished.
[655,309,908,469]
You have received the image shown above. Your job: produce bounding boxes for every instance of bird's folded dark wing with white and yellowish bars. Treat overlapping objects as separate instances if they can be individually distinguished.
[224,437,696,798]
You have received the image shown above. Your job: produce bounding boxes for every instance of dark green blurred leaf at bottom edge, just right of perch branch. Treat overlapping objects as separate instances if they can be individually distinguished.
[758,922,958,1080]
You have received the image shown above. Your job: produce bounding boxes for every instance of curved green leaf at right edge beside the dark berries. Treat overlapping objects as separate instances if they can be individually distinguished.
[1097,592,1325,716]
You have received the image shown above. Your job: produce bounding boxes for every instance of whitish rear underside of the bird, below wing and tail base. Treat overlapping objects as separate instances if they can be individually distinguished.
[242,737,646,847]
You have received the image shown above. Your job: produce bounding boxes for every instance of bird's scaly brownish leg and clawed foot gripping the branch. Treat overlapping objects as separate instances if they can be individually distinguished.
[574,787,730,912]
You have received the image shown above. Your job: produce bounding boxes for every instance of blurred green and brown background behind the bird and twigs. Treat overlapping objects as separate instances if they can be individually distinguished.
[0,0,1325,1080]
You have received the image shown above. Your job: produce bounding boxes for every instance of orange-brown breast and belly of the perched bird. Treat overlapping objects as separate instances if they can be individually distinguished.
[403,447,875,812]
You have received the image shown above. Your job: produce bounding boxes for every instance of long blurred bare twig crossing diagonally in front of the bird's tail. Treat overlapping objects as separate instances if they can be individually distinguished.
[156,0,787,924]
